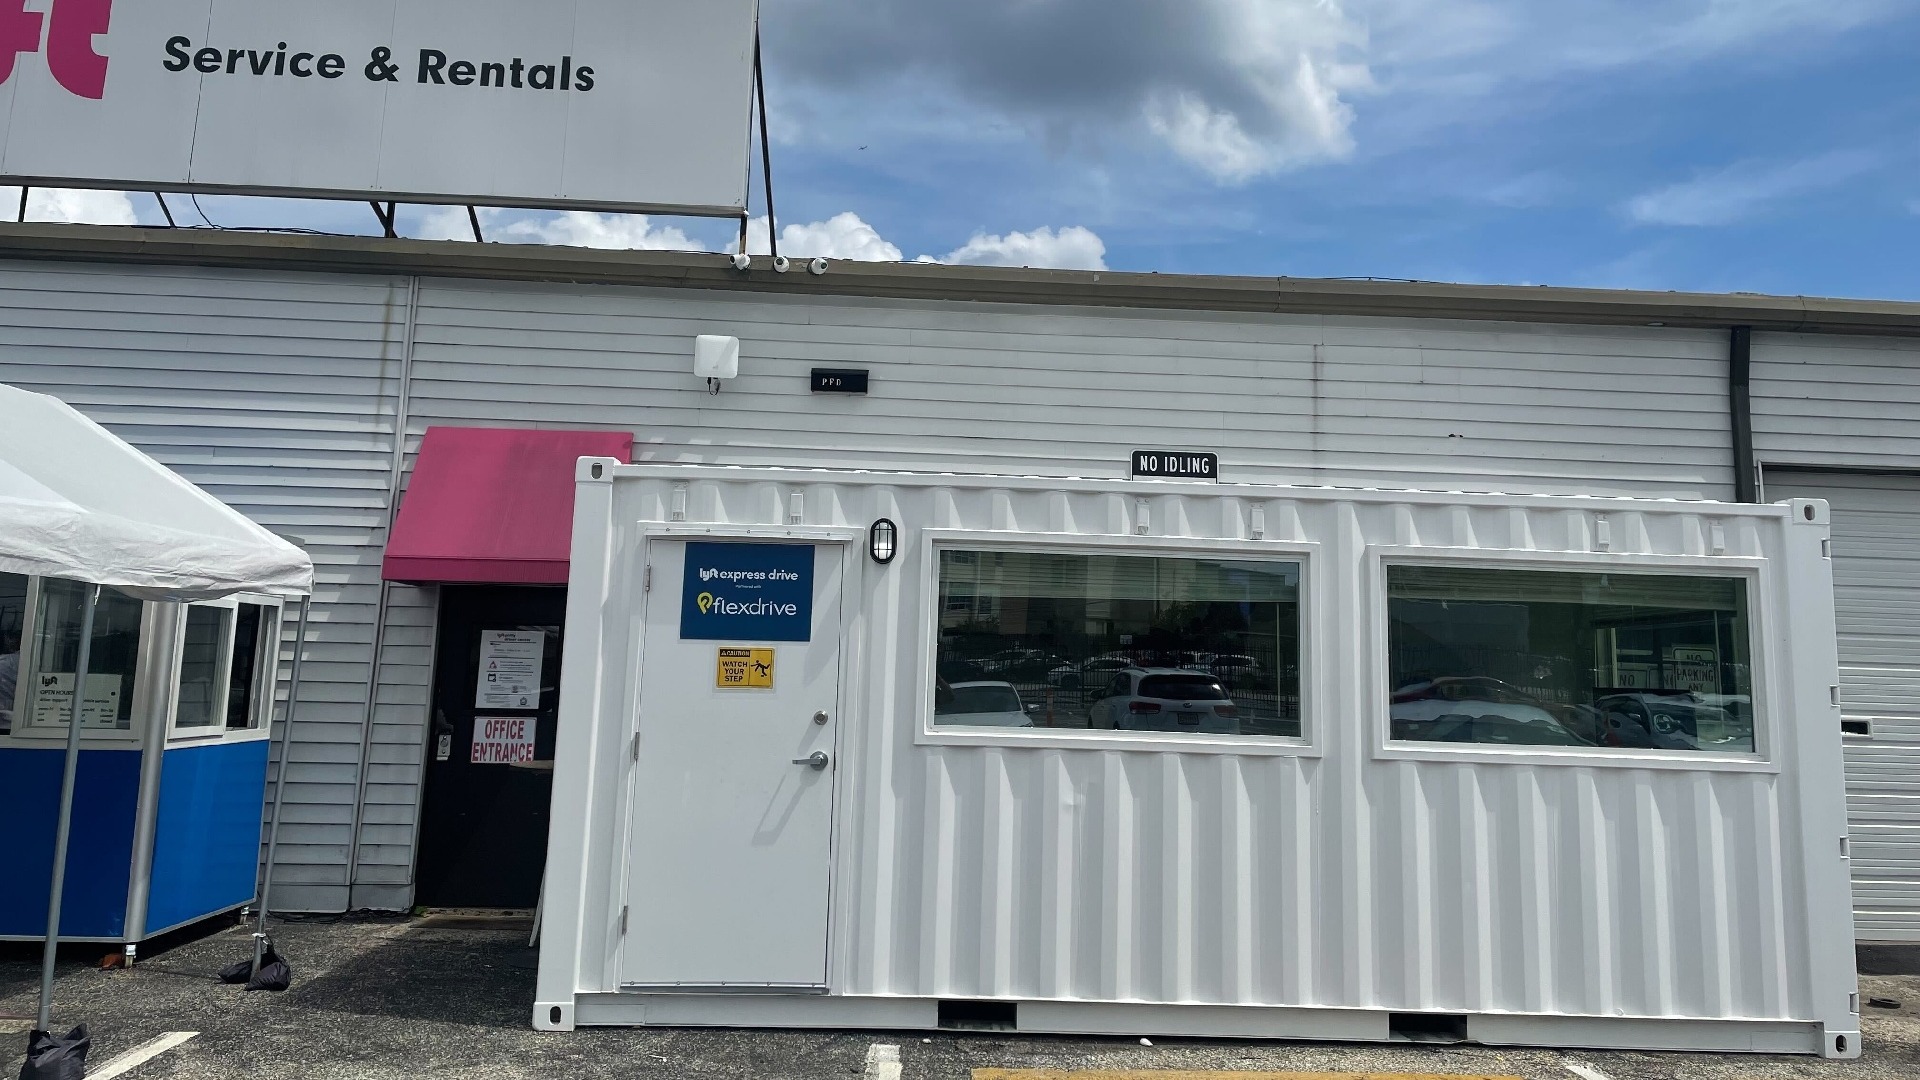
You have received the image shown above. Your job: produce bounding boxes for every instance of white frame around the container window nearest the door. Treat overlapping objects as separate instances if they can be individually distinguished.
[914,528,1331,757]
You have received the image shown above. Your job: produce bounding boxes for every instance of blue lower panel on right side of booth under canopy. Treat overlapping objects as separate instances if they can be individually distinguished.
[146,740,267,934]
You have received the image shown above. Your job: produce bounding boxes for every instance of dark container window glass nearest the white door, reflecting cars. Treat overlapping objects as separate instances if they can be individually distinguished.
[933,550,1302,738]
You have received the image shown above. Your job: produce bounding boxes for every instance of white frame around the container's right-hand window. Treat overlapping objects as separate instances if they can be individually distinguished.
[1363,544,1786,773]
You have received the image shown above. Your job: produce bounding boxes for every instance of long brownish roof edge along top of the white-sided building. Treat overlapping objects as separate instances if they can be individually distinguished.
[0,223,1920,336]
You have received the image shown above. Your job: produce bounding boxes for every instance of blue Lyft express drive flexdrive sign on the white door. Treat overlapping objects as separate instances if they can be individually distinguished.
[680,544,814,642]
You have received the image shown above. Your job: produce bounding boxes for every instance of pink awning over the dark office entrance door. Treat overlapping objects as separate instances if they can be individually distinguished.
[382,427,634,584]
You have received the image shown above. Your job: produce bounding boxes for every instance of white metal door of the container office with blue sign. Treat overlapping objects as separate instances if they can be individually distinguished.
[620,540,845,992]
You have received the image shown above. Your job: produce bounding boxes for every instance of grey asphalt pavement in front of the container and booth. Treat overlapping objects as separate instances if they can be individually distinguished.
[0,917,1920,1080]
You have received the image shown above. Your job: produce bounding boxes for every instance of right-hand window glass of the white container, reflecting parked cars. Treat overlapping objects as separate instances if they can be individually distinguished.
[1386,565,1755,753]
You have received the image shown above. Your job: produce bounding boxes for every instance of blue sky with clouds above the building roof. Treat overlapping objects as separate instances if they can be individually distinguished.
[18,0,1920,300]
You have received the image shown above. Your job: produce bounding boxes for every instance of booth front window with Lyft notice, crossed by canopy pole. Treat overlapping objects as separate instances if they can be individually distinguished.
[27,578,144,730]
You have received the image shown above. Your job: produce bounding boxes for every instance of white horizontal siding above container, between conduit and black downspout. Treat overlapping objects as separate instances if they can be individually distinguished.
[409,279,1732,498]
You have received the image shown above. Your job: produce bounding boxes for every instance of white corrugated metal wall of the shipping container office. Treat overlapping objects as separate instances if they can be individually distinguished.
[576,473,1851,1020]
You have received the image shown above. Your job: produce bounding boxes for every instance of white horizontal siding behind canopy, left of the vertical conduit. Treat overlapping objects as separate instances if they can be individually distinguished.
[0,263,407,911]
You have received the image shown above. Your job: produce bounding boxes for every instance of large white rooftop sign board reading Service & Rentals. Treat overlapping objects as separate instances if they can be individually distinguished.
[0,0,758,215]
